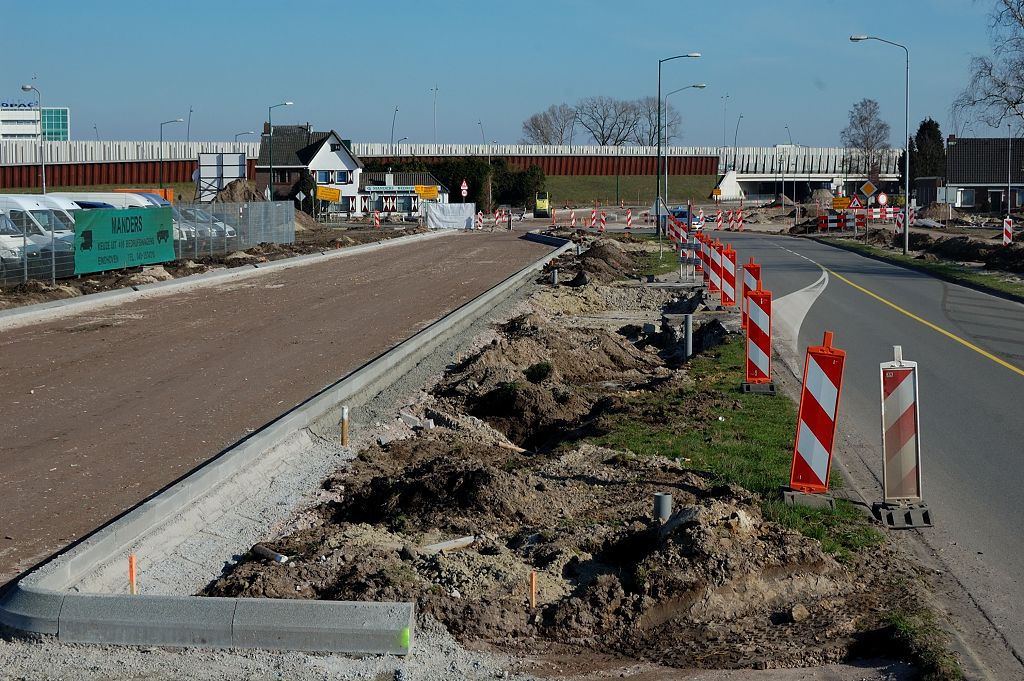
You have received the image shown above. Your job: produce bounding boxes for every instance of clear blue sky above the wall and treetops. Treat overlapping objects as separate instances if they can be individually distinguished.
[0,0,1007,145]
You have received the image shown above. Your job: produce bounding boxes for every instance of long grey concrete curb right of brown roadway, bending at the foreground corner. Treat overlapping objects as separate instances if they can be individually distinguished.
[0,233,573,654]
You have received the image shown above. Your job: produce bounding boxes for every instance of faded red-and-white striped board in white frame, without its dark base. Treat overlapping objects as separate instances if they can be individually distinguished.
[880,345,922,504]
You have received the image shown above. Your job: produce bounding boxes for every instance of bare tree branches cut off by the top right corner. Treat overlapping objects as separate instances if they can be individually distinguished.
[953,0,1024,127]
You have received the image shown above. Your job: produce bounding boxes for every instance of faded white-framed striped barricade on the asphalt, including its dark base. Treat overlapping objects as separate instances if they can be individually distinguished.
[873,345,932,529]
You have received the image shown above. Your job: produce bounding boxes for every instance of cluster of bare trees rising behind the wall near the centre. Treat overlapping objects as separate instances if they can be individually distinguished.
[522,96,682,146]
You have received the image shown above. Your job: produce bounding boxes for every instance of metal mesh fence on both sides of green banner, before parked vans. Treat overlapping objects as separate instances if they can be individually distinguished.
[0,201,295,286]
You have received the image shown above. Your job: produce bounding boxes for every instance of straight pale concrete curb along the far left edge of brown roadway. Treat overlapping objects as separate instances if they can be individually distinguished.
[0,230,459,330]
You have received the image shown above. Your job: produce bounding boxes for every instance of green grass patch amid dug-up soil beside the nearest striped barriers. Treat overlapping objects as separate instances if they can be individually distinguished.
[597,331,882,559]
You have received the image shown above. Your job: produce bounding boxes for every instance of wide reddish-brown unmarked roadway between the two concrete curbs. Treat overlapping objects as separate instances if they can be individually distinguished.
[0,231,551,584]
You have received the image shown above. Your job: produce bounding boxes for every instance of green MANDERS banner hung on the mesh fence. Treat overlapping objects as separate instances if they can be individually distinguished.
[75,208,174,274]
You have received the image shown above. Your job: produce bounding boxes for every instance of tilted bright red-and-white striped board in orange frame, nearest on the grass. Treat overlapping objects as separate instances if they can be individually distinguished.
[790,331,846,494]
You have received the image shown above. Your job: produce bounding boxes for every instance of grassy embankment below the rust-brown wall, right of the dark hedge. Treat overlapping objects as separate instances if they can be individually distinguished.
[545,175,718,205]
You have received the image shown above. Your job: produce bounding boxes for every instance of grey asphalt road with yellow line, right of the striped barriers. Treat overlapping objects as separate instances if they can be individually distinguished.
[720,225,1024,673]
